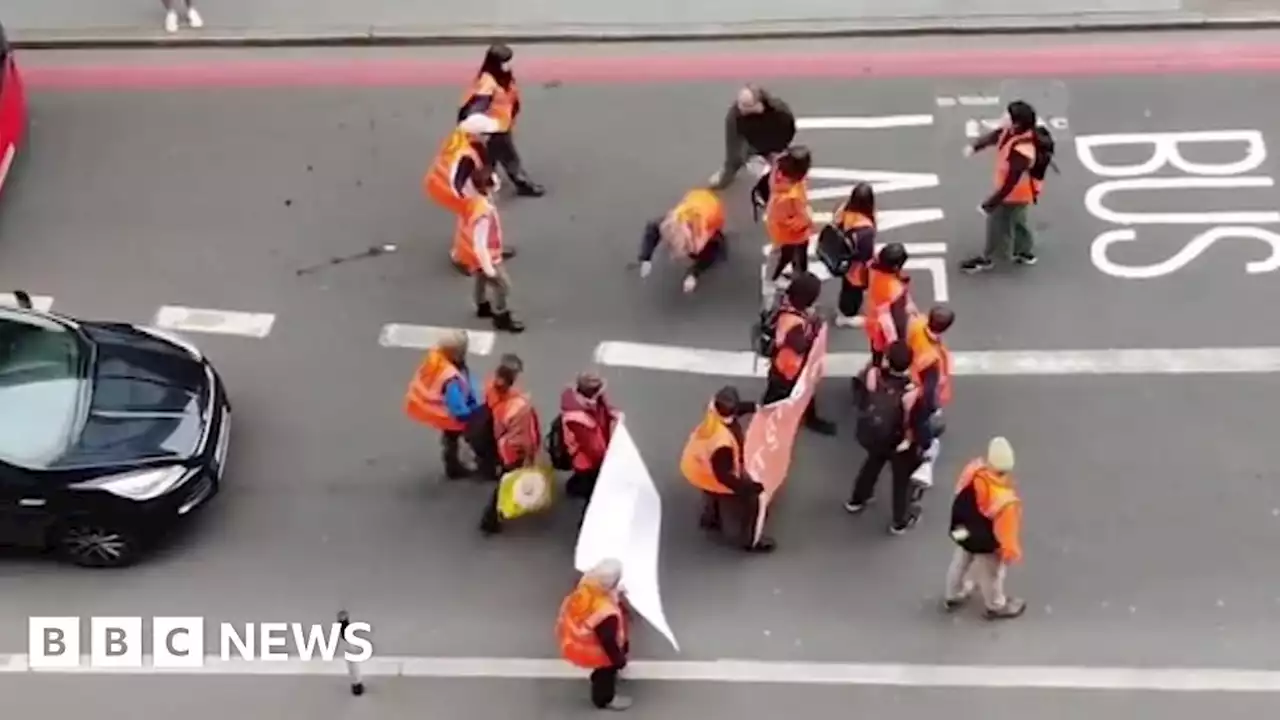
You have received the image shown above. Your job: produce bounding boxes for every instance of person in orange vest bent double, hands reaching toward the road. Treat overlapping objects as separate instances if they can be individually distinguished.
[639,188,727,292]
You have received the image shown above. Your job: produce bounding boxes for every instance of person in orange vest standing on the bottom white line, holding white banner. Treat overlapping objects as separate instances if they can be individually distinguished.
[556,559,631,710]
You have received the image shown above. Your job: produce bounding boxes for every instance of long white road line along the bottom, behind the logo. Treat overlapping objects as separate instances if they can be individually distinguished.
[0,655,1280,693]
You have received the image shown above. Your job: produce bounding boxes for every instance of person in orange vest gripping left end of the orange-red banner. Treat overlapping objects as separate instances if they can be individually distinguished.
[680,387,777,552]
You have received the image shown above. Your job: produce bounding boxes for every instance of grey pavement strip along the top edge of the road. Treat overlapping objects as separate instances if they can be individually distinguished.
[0,0,1280,46]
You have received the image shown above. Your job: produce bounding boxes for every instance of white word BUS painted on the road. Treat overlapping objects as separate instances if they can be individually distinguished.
[1075,129,1280,279]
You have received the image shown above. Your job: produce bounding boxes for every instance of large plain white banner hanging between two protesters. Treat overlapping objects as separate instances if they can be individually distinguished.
[573,423,680,651]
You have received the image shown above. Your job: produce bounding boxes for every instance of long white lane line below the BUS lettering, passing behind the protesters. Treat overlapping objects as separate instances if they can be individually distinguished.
[595,342,1280,378]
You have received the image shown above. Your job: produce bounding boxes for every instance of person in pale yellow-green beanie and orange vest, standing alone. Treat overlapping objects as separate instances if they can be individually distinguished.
[942,437,1027,620]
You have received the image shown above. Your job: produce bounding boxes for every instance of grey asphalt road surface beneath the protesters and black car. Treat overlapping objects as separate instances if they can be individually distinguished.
[0,37,1280,717]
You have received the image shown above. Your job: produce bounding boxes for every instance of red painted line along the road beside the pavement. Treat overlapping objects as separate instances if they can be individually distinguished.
[23,44,1280,90]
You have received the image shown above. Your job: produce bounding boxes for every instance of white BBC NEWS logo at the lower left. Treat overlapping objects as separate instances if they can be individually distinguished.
[27,618,374,669]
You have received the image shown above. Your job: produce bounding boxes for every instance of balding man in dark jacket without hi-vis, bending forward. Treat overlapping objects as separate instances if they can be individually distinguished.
[710,85,796,190]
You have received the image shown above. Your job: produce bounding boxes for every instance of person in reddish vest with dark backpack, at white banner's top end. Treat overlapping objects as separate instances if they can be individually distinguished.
[561,373,621,518]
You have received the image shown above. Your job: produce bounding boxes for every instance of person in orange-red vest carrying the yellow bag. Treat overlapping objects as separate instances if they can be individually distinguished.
[476,355,543,536]
